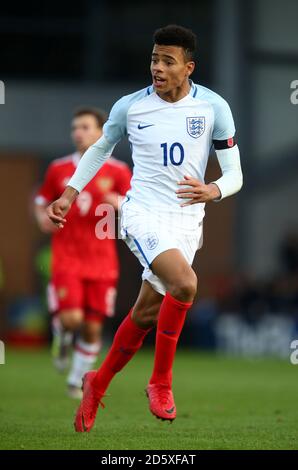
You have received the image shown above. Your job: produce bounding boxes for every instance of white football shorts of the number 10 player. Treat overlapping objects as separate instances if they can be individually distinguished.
[120,197,203,295]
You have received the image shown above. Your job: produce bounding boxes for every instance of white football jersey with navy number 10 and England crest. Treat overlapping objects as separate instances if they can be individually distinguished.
[103,82,235,223]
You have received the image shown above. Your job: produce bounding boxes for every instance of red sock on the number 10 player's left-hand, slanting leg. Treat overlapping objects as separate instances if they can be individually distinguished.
[93,309,151,394]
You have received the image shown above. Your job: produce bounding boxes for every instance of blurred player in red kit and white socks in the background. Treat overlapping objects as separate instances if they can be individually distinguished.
[35,107,131,398]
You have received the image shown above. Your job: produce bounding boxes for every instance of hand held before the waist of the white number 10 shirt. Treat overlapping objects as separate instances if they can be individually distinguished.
[176,175,221,207]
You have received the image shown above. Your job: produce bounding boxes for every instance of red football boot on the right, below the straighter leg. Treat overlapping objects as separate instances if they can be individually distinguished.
[145,384,176,421]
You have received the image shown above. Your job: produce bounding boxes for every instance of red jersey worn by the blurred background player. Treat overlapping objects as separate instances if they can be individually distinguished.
[35,153,131,280]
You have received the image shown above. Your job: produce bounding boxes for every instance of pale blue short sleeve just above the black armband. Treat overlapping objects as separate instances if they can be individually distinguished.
[212,96,235,140]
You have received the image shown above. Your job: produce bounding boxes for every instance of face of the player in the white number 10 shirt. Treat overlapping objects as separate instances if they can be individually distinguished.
[150,44,195,96]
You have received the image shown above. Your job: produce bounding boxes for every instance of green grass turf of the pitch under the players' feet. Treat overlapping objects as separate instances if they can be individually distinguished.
[0,350,298,450]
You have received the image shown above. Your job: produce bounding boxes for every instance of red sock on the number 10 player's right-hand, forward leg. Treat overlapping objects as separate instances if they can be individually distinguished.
[149,292,192,387]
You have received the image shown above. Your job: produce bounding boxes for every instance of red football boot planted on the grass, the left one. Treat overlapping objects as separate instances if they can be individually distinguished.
[74,370,105,432]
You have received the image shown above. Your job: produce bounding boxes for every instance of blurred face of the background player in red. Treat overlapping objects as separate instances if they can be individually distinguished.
[71,114,102,153]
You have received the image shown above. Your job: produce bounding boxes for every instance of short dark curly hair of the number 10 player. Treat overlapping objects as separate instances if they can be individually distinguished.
[153,24,197,60]
